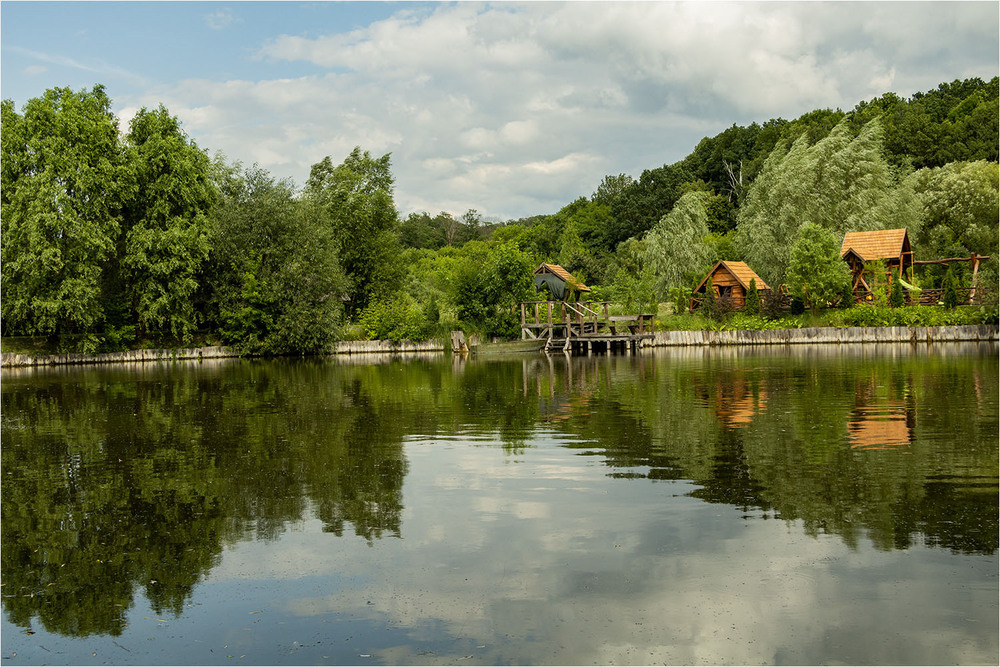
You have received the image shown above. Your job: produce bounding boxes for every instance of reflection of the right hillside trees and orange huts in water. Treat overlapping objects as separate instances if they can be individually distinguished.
[525,346,998,553]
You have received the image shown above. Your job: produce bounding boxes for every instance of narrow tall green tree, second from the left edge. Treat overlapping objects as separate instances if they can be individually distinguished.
[116,105,216,335]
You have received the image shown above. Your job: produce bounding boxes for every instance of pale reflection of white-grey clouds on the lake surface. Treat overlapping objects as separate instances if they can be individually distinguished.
[207,442,996,664]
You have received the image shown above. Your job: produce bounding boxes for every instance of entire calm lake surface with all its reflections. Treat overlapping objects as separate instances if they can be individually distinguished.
[0,344,1000,665]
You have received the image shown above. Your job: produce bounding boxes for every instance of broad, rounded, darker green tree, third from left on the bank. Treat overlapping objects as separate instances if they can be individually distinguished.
[209,164,347,354]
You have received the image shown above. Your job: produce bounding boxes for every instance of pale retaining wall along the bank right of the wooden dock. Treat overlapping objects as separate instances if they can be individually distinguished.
[643,324,1000,347]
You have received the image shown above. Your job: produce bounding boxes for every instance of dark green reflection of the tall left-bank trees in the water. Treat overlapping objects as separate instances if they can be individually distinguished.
[0,362,422,635]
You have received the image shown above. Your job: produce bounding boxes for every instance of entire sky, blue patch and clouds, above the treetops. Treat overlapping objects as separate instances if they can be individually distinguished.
[0,0,1000,220]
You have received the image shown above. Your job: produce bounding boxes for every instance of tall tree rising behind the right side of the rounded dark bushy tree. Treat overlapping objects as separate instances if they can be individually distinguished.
[305,147,405,312]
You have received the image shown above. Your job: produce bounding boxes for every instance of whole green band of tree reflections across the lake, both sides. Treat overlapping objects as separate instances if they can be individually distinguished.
[0,345,998,636]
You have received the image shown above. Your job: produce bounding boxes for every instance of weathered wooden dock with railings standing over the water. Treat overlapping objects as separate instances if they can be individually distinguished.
[521,301,654,353]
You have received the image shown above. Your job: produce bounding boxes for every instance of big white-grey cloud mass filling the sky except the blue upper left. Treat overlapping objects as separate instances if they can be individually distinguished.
[130,2,998,217]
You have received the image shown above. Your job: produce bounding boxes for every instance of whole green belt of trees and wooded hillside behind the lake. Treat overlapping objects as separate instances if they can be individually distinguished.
[0,77,1000,354]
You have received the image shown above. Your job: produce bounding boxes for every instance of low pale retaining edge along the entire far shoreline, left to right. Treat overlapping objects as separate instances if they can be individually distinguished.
[0,324,1000,368]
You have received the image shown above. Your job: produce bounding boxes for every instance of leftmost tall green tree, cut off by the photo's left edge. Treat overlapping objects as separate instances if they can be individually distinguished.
[0,86,129,334]
